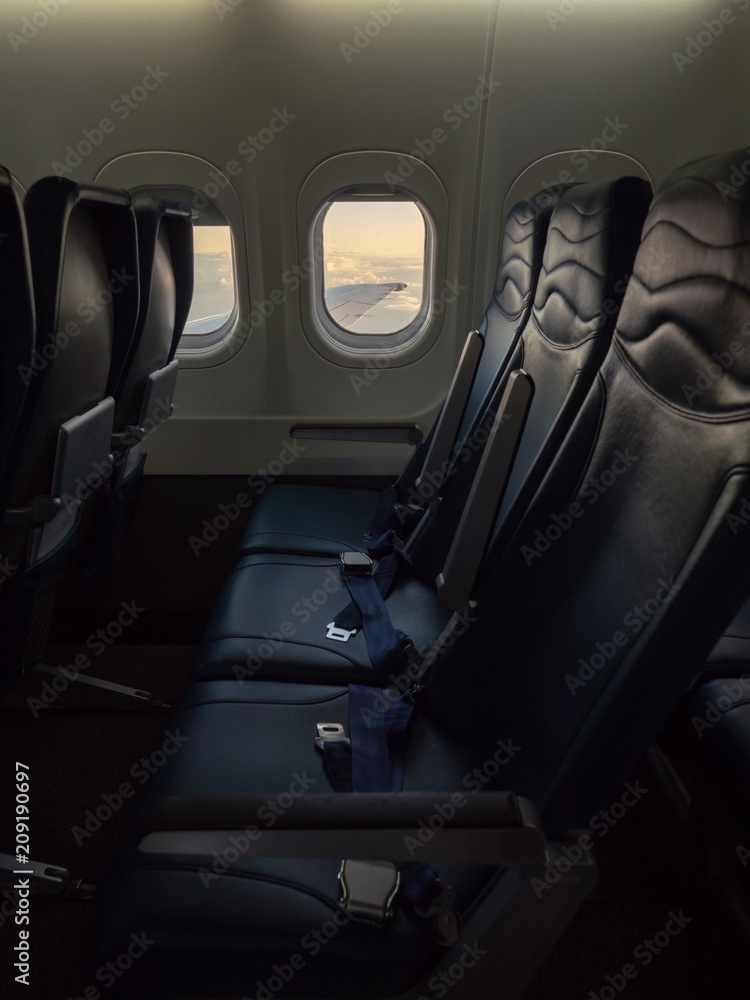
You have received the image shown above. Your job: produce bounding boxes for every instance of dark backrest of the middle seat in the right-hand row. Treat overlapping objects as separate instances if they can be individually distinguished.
[414,177,651,580]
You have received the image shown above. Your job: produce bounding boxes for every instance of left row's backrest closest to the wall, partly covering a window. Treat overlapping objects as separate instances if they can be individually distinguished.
[114,195,193,433]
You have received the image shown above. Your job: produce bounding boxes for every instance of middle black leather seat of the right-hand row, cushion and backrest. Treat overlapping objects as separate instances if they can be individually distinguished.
[196,178,650,684]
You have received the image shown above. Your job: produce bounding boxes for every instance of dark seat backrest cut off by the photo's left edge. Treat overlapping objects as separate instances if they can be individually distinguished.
[0,167,34,510]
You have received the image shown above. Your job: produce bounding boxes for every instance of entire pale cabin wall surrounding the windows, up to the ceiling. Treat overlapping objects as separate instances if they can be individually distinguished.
[0,0,750,474]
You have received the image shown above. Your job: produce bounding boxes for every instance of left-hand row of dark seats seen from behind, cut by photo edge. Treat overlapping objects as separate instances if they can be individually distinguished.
[0,168,193,691]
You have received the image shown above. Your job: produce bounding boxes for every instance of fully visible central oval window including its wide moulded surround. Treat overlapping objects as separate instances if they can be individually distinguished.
[297,150,450,368]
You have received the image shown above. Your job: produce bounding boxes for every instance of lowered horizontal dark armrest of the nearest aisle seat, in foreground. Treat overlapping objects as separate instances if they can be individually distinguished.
[136,791,546,867]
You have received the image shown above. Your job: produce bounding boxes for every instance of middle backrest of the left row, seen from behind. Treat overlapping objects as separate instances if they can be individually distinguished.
[4,177,139,507]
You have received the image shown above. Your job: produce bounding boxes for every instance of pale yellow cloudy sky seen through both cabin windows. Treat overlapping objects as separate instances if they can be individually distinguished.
[187,198,425,334]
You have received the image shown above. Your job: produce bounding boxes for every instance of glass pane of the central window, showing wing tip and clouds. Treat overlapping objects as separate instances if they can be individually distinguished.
[321,197,427,343]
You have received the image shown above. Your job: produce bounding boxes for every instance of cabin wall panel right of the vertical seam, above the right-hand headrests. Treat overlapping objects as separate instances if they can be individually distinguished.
[474,0,750,316]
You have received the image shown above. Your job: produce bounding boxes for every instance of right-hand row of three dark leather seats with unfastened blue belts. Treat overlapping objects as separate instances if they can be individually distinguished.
[92,150,750,1000]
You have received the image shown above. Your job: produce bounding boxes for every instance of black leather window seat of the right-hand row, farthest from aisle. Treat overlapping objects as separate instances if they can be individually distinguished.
[239,194,556,556]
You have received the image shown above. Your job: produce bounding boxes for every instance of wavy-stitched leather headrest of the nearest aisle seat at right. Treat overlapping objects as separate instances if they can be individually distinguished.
[616,149,750,418]
